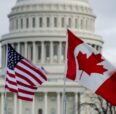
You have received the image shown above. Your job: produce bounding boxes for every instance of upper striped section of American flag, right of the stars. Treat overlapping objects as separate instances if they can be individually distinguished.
[14,59,47,87]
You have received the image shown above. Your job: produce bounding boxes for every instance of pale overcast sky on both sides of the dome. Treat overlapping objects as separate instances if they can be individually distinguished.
[0,0,116,66]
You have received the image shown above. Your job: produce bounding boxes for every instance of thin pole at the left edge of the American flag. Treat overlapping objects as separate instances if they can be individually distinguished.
[4,44,8,114]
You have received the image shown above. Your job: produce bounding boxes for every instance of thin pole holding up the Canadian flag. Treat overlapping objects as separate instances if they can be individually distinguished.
[63,25,68,114]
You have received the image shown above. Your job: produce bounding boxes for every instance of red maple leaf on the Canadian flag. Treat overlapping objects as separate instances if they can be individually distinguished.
[77,52,107,79]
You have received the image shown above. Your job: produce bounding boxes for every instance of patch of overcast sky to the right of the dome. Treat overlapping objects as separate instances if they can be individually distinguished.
[89,0,116,66]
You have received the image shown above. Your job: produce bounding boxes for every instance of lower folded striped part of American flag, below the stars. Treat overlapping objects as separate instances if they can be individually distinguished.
[5,69,37,101]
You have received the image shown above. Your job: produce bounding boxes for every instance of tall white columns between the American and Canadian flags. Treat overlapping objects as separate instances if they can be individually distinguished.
[17,41,65,64]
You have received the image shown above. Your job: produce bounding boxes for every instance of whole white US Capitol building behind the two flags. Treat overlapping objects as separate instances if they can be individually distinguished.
[0,0,103,114]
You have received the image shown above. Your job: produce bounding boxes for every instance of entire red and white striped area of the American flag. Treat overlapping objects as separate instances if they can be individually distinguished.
[6,59,47,101]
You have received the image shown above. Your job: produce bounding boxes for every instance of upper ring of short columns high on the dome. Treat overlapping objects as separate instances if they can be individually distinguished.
[10,16,95,31]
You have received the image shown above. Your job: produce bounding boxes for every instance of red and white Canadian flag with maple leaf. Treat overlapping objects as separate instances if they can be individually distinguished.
[66,30,116,105]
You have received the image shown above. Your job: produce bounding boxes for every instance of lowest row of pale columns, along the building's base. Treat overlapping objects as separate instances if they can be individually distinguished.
[1,92,80,114]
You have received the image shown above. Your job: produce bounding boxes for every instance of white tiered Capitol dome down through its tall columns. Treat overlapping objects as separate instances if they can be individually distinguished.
[1,0,103,68]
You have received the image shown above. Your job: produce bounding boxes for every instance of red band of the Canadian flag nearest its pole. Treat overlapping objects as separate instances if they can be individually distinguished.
[66,30,83,80]
